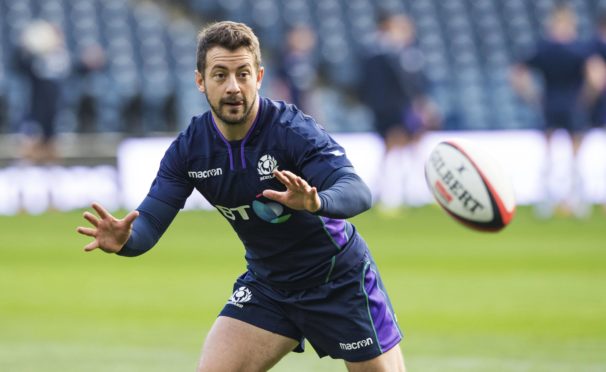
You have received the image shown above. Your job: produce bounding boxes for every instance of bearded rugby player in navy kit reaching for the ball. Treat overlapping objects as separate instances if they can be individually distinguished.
[78,22,404,371]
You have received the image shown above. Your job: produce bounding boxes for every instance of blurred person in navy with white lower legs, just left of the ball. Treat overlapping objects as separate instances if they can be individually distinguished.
[360,14,440,210]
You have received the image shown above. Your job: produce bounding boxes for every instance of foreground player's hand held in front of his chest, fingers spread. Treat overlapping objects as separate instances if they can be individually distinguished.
[263,170,322,213]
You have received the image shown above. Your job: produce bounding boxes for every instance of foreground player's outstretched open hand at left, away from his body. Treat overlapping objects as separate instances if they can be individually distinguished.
[76,203,139,253]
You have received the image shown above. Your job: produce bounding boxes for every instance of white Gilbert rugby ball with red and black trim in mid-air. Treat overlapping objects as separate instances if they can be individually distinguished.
[425,139,516,231]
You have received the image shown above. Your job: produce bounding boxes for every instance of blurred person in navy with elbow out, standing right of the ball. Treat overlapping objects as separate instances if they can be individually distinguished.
[512,5,591,217]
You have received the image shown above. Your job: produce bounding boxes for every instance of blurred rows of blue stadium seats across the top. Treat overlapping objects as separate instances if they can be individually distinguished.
[0,0,606,134]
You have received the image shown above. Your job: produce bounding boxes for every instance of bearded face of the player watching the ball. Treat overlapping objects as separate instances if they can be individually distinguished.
[196,47,263,125]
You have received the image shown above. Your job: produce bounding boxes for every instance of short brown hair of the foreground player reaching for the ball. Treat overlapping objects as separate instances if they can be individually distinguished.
[196,21,261,75]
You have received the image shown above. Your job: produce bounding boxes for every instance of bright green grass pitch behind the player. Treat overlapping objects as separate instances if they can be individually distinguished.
[0,207,606,372]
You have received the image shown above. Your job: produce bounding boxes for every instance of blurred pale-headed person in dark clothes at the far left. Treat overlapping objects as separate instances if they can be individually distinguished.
[17,20,70,163]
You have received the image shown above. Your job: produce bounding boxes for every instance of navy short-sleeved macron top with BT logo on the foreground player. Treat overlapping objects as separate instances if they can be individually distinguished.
[129,98,367,289]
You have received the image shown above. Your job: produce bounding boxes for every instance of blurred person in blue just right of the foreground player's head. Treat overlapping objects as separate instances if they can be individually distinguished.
[276,24,318,114]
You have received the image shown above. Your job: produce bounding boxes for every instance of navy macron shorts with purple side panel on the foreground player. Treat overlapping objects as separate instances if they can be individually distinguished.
[220,253,402,362]
